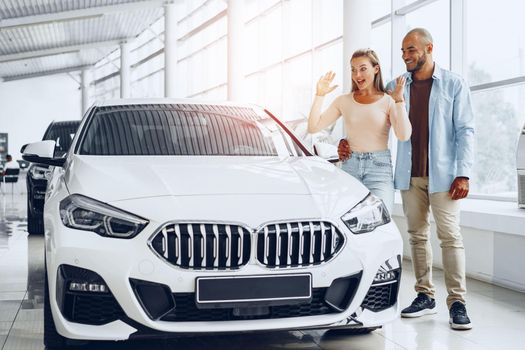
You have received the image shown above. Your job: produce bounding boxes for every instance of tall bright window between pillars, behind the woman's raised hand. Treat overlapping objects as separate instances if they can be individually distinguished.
[244,0,342,121]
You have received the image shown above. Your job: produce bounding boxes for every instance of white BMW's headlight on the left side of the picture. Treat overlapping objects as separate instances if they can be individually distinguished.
[60,194,149,238]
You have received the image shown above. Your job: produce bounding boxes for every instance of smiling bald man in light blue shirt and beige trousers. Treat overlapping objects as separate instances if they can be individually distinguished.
[339,28,474,329]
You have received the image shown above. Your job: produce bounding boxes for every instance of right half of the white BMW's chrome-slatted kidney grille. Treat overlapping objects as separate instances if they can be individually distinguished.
[257,221,343,268]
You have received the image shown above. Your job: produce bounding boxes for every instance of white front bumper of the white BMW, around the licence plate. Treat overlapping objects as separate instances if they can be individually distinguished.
[45,196,402,340]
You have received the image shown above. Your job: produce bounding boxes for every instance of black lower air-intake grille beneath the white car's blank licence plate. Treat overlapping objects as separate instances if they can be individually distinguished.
[161,288,338,322]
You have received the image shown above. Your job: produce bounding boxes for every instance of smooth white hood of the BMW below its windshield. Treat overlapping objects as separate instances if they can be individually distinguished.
[64,156,368,202]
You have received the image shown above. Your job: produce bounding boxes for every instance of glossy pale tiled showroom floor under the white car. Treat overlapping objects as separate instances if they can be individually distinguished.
[0,194,525,350]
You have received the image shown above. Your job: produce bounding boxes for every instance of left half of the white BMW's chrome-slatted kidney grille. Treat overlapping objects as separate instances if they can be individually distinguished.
[149,223,251,270]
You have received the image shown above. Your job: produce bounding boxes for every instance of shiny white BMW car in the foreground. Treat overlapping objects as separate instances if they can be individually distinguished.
[24,99,402,347]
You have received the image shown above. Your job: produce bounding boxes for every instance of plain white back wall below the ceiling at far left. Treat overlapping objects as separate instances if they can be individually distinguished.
[0,74,81,159]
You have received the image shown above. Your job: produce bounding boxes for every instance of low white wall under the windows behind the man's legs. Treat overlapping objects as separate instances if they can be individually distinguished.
[393,199,525,292]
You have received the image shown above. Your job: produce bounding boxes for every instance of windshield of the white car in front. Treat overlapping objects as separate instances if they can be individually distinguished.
[79,105,303,156]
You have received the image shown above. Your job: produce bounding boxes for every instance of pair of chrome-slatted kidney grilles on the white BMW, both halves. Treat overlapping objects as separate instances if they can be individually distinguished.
[149,221,344,270]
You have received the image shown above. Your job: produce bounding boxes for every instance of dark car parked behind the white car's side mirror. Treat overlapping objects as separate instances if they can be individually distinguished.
[26,120,80,234]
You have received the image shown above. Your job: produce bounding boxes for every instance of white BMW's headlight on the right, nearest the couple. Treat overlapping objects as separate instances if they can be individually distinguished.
[341,194,390,234]
